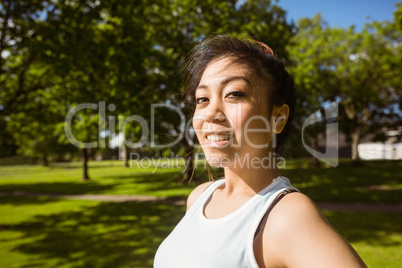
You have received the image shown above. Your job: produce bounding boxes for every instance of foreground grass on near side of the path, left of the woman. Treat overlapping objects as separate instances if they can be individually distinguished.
[0,197,184,268]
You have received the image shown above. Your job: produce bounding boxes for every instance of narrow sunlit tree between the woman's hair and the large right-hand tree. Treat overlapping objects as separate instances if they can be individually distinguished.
[287,14,340,166]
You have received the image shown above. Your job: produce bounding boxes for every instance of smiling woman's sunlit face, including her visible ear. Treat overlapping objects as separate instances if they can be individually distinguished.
[193,58,278,167]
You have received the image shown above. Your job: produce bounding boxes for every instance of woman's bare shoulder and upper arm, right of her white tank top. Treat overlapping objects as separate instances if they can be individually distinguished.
[261,193,365,267]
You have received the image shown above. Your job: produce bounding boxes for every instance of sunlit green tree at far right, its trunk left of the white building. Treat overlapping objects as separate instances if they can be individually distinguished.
[292,10,401,161]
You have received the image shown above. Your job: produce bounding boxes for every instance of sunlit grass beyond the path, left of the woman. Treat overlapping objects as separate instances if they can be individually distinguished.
[0,161,196,197]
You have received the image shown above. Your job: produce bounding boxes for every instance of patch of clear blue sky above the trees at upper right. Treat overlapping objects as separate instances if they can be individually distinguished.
[278,0,401,30]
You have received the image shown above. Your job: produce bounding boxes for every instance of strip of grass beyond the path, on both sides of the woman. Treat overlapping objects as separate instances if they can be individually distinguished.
[0,160,402,203]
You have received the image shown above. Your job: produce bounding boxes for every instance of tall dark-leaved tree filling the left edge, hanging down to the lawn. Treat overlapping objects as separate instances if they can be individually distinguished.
[0,0,80,165]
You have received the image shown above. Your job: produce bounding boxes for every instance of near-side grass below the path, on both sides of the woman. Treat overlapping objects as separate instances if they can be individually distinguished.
[0,197,402,267]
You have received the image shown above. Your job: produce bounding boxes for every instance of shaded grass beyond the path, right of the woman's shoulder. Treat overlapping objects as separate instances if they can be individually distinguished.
[283,161,402,203]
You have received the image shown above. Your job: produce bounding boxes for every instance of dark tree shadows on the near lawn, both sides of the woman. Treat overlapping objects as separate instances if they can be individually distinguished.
[2,199,402,268]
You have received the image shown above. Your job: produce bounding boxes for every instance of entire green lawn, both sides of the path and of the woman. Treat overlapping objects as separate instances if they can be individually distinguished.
[0,161,402,268]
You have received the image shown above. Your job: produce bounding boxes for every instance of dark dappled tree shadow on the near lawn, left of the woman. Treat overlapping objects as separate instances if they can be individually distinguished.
[3,202,184,268]
